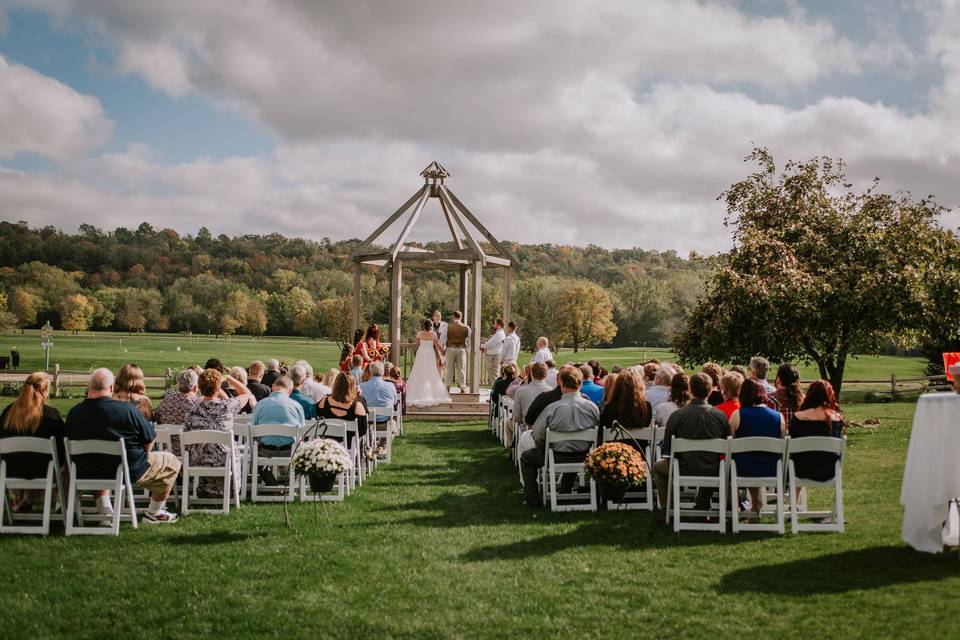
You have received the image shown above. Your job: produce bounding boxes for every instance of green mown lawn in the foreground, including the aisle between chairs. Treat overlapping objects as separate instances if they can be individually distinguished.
[0,401,960,638]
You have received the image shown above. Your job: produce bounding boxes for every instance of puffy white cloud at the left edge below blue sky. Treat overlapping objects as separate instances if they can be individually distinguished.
[0,55,113,160]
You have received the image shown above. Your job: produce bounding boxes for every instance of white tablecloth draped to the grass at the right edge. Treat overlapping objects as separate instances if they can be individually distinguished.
[900,393,960,553]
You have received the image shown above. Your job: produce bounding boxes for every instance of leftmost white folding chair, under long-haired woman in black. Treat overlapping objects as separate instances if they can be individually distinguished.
[0,436,66,536]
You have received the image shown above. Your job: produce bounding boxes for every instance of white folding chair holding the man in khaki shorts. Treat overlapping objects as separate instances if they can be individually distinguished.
[63,438,137,536]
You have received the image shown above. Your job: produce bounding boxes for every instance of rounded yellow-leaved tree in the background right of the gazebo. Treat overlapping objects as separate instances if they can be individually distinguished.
[557,280,617,353]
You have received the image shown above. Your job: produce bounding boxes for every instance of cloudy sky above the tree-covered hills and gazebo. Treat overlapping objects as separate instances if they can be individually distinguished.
[0,0,960,253]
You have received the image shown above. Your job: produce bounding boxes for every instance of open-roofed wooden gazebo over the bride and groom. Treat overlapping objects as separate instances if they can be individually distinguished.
[350,162,517,393]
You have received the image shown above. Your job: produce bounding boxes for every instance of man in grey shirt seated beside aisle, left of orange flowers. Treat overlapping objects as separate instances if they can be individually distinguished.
[520,367,600,507]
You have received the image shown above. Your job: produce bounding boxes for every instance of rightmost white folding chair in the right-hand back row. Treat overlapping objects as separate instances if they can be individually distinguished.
[787,436,847,533]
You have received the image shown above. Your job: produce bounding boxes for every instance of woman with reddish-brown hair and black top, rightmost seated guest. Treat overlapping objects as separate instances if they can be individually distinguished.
[789,380,843,482]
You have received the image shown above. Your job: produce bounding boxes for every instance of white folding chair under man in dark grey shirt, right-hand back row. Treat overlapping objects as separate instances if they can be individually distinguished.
[666,436,729,533]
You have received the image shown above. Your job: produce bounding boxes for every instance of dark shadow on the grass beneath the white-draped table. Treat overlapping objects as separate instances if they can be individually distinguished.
[717,545,960,595]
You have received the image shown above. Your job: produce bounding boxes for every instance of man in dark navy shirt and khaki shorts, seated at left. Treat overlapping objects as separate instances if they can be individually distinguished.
[67,369,180,524]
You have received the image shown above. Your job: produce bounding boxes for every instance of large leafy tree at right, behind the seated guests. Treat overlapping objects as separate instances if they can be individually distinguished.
[675,149,950,392]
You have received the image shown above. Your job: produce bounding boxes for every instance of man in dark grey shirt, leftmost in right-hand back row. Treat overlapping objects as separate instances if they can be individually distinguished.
[653,373,730,510]
